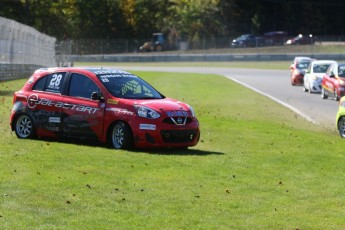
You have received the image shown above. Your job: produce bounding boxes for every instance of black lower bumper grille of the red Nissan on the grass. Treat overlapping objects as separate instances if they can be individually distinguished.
[161,130,198,143]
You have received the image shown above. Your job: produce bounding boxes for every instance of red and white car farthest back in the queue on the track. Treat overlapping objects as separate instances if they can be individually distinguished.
[290,57,315,85]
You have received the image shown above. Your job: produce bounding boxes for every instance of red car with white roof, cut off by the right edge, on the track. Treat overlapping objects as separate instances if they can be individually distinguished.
[321,63,345,101]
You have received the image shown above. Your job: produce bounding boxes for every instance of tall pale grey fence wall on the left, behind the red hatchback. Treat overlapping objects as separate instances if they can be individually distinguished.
[0,17,56,81]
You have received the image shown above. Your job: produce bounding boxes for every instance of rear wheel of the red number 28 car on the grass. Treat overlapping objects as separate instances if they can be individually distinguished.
[13,114,36,139]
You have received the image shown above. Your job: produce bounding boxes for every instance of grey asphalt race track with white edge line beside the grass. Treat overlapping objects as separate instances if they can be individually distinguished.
[117,66,338,129]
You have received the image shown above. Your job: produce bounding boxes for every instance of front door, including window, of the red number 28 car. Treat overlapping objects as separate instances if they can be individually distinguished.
[62,73,105,139]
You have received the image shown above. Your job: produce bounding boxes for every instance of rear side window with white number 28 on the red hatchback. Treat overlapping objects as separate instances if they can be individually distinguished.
[33,72,66,93]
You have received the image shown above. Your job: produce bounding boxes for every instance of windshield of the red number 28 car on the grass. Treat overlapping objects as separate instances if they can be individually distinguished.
[97,72,164,99]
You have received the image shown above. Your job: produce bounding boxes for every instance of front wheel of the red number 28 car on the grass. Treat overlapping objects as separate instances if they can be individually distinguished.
[110,121,133,149]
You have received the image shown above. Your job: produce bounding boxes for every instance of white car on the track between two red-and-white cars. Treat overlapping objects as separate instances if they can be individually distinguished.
[303,60,336,93]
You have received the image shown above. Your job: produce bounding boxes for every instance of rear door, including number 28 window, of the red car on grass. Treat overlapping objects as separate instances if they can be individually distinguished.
[28,72,66,136]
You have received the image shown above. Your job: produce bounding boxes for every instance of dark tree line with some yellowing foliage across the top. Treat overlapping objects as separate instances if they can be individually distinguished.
[0,0,345,40]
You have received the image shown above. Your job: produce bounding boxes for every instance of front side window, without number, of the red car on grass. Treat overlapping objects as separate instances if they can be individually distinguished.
[68,73,100,98]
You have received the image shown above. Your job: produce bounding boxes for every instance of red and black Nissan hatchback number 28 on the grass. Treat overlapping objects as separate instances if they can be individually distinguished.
[10,67,200,149]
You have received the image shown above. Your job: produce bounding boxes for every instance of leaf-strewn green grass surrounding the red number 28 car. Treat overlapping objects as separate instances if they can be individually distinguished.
[0,72,345,229]
